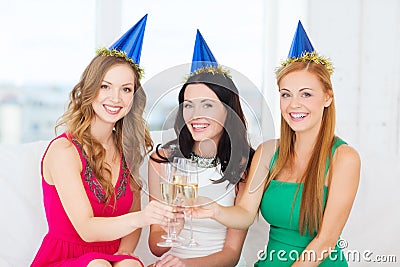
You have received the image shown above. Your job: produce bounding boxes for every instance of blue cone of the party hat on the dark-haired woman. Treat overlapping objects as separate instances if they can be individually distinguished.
[190,30,218,73]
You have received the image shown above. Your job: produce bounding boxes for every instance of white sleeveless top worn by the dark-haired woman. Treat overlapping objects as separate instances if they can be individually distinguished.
[169,164,246,267]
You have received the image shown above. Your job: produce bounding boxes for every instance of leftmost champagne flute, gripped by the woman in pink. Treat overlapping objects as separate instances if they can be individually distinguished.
[157,163,180,247]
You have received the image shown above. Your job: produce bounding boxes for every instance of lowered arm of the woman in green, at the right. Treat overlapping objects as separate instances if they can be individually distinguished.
[293,145,361,266]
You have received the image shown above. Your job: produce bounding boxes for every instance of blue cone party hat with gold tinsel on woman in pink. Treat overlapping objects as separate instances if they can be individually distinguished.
[97,14,147,77]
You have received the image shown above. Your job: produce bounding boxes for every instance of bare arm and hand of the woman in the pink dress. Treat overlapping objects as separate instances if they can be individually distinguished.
[43,138,173,242]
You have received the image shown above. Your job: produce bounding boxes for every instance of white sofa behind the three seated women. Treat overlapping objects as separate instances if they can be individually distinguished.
[0,131,268,267]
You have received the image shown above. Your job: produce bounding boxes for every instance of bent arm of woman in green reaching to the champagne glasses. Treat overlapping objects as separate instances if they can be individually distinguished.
[193,140,276,230]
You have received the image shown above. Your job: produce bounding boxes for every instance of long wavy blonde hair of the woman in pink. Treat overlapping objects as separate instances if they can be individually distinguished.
[55,56,153,205]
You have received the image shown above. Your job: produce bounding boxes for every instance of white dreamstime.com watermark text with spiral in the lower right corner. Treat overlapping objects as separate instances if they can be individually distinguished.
[257,238,397,263]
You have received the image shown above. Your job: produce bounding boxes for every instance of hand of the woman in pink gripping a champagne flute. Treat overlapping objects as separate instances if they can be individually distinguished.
[139,200,174,227]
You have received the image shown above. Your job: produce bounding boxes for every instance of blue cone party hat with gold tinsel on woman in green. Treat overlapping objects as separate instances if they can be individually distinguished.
[277,20,333,74]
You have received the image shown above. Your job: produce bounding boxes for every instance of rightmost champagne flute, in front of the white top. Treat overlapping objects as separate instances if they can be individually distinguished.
[173,158,199,247]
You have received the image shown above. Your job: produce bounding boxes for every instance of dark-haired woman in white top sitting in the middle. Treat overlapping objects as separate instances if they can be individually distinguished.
[149,69,254,266]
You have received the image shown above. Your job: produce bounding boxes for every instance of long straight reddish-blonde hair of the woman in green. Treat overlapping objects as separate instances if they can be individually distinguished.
[267,61,336,237]
